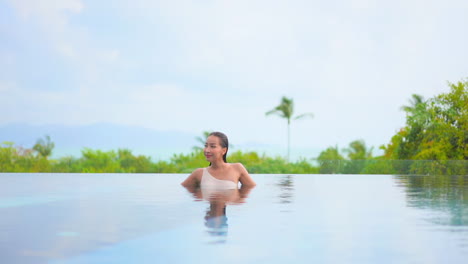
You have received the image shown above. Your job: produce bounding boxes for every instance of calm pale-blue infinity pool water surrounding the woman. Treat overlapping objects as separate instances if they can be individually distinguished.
[0,174,468,264]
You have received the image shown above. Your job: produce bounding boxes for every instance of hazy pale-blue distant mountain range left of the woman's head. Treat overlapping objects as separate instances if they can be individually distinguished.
[0,123,199,160]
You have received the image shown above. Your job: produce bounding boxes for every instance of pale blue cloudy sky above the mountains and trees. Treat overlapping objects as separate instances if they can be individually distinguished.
[0,0,468,157]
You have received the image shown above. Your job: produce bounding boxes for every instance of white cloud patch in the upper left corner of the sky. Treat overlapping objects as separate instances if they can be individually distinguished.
[5,0,120,86]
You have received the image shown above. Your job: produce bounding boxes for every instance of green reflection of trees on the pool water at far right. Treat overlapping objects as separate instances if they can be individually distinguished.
[395,175,468,227]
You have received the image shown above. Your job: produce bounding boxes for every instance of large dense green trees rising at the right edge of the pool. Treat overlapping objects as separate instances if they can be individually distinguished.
[382,81,468,175]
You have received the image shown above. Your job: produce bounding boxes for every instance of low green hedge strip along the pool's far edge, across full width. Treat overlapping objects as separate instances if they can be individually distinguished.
[0,142,468,175]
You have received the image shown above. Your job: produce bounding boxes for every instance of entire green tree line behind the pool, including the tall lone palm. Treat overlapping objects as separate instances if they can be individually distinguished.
[0,80,468,175]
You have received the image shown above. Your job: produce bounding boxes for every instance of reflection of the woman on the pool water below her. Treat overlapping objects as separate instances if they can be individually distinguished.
[186,186,253,244]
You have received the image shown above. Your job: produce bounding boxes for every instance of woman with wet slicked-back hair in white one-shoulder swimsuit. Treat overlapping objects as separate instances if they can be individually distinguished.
[182,132,256,189]
